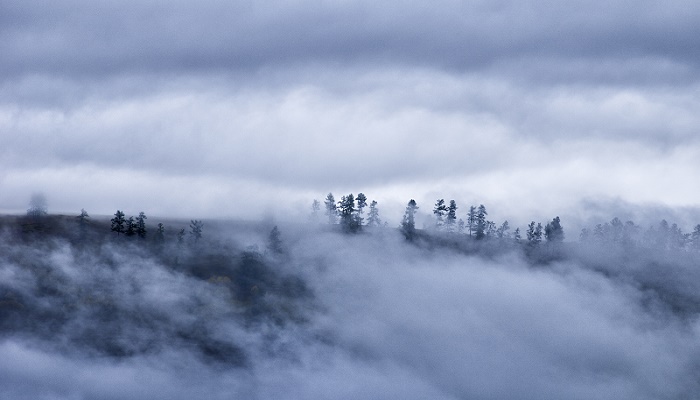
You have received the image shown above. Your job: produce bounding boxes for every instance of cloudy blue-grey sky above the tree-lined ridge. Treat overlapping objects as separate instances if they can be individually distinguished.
[0,0,700,229]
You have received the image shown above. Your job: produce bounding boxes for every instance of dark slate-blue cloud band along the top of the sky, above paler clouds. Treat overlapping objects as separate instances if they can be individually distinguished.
[0,1,700,84]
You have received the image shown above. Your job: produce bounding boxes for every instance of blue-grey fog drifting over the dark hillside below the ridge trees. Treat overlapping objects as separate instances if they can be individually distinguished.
[0,216,700,399]
